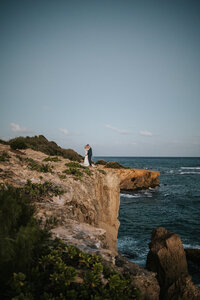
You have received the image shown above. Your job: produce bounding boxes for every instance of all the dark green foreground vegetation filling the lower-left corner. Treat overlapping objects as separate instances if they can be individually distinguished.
[0,181,140,300]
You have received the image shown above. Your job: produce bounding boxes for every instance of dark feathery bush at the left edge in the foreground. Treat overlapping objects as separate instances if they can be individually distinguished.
[0,186,48,299]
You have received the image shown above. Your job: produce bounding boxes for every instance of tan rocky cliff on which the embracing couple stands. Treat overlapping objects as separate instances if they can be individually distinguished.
[0,144,160,300]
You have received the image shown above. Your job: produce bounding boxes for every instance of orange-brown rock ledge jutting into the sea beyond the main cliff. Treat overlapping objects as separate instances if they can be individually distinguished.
[115,169,160,191]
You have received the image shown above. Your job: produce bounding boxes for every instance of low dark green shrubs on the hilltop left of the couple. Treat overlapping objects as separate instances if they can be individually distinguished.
[7,135,82,162]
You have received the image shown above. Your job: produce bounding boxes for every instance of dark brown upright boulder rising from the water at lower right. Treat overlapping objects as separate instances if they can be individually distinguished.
[146,227,200,300]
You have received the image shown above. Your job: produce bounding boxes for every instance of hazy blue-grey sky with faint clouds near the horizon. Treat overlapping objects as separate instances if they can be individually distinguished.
[0,0,200,156]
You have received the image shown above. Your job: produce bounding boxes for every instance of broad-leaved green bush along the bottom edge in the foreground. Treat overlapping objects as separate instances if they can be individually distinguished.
[8,240,140,300]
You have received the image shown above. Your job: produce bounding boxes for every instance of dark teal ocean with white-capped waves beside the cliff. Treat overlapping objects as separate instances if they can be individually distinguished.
[94,157,200,285]
